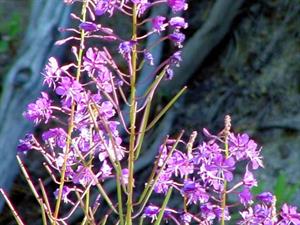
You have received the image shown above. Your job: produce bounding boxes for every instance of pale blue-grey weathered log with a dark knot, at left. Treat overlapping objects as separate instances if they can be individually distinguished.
[0,0,69,210]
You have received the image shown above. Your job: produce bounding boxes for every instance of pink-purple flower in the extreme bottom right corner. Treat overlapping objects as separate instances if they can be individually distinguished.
[278,204,300,225]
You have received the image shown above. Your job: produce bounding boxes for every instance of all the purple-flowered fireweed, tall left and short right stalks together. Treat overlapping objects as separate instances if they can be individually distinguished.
[1,0,300,225]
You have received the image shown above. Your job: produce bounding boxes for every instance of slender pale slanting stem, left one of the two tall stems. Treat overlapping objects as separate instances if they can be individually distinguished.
[52,0,88,225]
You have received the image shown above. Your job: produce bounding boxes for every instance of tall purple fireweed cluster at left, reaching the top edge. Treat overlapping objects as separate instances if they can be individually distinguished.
[14,0,188,225]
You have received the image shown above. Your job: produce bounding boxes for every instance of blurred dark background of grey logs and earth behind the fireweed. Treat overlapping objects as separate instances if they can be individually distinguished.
[0,0,300,225]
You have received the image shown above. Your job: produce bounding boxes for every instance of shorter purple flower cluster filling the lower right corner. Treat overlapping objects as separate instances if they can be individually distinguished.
[144,129,300,225]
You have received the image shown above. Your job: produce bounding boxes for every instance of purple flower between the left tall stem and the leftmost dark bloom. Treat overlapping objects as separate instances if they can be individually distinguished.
[42,128,67,148]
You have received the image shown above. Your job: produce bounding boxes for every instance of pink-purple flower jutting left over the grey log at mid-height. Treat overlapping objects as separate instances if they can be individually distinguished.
[23,92,52,124]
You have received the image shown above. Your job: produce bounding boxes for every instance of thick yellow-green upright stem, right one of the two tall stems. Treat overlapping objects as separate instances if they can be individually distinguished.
[126,4,137,225]
